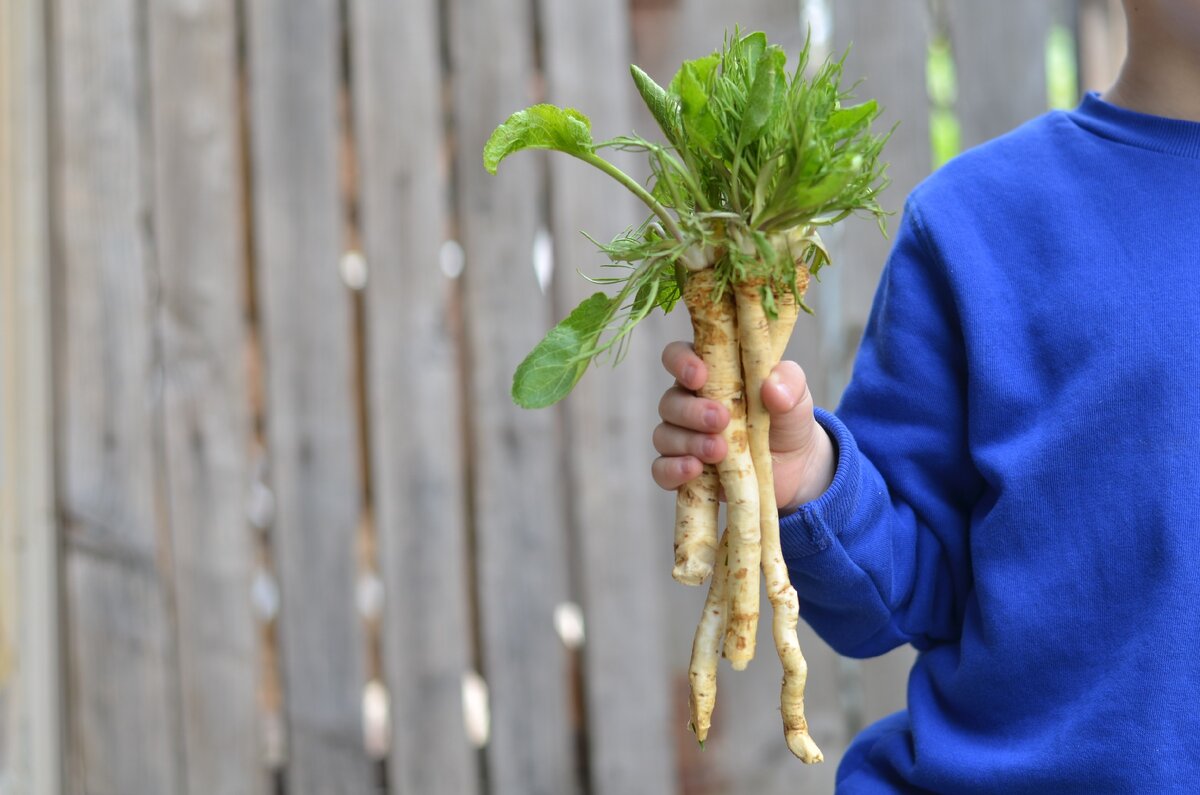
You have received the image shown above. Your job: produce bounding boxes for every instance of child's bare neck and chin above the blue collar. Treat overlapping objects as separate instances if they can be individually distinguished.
[1104,11,1200,121]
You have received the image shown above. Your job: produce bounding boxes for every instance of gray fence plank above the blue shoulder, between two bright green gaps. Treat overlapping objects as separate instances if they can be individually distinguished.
[946,0,1055,149]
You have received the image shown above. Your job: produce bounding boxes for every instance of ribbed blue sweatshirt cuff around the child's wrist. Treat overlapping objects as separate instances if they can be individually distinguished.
[779,408,863,561]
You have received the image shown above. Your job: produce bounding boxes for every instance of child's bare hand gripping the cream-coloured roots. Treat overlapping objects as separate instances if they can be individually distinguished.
[650,342,835,513]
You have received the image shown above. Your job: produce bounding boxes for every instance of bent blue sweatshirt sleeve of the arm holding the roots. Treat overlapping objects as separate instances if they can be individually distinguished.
[780,201,984,657]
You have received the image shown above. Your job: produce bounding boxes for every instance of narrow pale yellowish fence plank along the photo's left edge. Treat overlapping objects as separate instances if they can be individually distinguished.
[0,0,62,795]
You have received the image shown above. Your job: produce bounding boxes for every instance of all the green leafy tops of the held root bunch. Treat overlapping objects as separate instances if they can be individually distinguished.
[484,30,887,408]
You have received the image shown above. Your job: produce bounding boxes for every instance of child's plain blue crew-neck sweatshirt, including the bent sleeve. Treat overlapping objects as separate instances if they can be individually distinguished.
[781,95,1200,795]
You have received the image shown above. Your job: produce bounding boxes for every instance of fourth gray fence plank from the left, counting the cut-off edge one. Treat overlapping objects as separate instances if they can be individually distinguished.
[246,0,373,795]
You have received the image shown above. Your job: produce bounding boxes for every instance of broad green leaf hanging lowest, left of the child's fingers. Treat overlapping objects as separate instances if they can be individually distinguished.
[512,293,617,408]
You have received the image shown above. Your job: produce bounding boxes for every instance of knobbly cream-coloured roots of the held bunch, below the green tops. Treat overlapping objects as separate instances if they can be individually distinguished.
[674,252,823,764]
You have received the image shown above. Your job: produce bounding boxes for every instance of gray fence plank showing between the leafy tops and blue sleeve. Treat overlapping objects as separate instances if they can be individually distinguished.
[817,0,930,731]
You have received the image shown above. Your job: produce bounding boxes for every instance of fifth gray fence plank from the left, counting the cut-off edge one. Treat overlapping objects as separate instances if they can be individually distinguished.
[350,0,479,795]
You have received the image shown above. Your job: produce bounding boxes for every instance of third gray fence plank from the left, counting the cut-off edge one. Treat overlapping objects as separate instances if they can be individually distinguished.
[148,0,266,795]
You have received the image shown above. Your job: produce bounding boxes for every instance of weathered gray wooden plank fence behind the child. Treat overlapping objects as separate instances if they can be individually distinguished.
[0,0,1120,795]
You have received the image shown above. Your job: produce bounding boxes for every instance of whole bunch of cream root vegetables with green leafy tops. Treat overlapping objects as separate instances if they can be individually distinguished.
[484,31,887,763]
